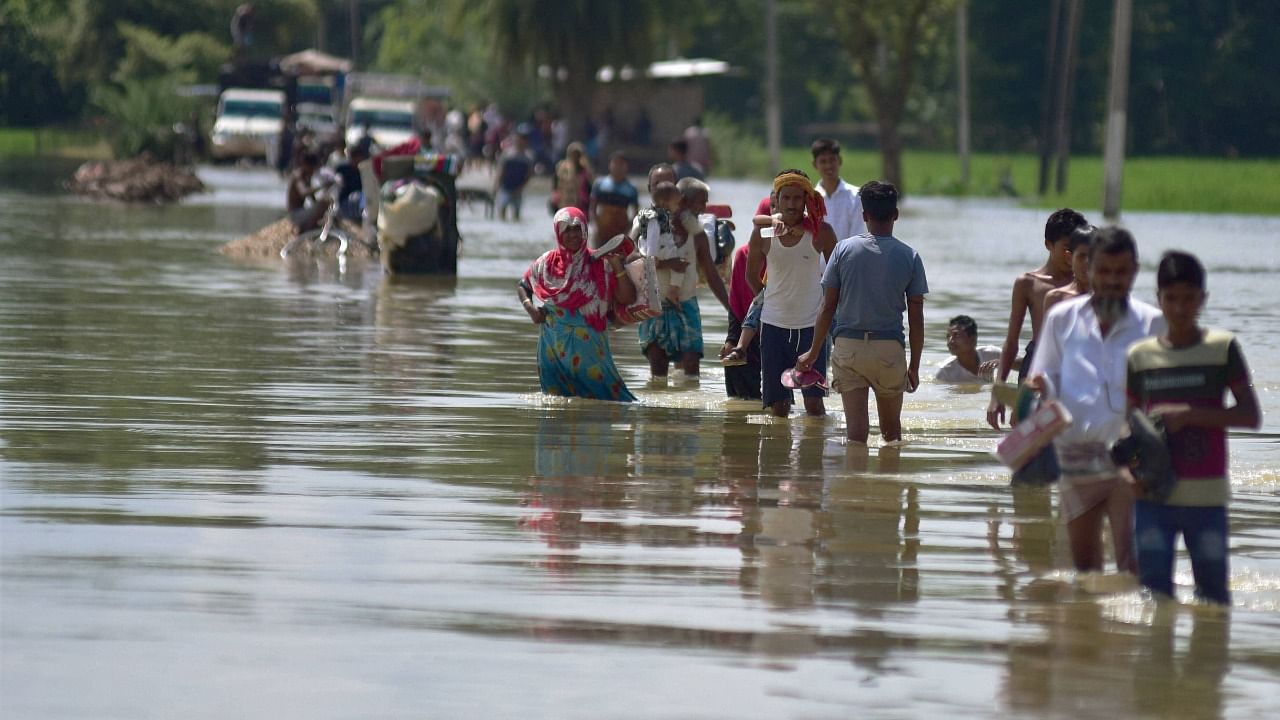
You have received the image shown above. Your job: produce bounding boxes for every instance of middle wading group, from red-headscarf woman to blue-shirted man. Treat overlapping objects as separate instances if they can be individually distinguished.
[518,140,928,443]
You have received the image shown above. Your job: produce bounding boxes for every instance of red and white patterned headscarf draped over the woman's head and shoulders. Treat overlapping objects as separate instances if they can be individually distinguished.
[525,208,617,331]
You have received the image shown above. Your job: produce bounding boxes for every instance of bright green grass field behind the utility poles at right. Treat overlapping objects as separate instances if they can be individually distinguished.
[782,147,1280,215]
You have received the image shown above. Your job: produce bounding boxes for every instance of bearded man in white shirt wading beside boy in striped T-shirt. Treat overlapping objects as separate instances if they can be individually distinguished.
[1028,227,1165,573]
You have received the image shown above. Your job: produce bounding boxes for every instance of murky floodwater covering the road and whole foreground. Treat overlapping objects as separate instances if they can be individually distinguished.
[0,159,1280,720]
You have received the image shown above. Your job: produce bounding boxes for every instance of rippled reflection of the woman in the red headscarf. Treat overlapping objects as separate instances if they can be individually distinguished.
[520,407,625,573]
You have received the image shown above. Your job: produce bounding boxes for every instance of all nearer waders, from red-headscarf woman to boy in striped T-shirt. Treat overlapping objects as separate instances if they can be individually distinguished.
[518,135,1261,605]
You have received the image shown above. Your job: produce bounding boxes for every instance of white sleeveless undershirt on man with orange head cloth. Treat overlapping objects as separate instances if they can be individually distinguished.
[760,232,823,329]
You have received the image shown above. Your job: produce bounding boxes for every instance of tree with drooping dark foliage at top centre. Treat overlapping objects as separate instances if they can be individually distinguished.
[462,0,672,144]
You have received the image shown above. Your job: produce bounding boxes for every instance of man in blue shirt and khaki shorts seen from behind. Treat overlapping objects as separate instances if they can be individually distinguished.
[796,181,929,443]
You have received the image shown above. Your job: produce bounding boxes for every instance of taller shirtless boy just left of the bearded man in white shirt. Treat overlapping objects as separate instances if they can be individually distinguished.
[987,208,1088,430]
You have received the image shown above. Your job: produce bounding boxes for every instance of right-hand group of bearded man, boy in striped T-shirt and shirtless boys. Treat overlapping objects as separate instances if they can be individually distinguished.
[987,209,1261,605]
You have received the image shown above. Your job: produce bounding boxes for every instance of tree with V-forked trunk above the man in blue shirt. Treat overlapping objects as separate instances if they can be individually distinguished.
[820,0,955,188]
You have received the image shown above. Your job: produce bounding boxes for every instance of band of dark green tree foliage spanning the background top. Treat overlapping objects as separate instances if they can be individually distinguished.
[0,0,1280,161]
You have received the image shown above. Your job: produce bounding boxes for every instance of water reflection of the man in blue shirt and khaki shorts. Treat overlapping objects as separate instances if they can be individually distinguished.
[818,445,920,616]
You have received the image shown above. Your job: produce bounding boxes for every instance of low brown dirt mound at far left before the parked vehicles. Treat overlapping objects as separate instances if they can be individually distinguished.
[67,154,205,202]
